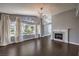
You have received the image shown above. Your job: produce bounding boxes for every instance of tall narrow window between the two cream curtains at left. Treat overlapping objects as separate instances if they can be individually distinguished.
[9,20,16,43]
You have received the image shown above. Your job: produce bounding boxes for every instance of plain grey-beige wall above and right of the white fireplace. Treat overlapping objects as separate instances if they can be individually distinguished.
[53,10,79,43]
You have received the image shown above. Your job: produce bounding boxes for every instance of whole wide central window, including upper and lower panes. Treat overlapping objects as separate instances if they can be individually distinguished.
[20,17,36,40]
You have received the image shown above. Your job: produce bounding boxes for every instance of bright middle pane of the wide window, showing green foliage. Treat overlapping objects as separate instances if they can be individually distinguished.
[21,23,35,35]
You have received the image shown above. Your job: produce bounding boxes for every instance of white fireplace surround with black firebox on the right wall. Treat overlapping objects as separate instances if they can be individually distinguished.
[53,29,68,43]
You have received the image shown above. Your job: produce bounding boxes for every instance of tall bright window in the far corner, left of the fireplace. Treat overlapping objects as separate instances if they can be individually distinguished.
[43,15,52,36]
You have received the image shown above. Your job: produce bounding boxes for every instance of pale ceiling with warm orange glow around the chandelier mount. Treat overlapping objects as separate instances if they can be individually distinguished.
[0,3,77,15]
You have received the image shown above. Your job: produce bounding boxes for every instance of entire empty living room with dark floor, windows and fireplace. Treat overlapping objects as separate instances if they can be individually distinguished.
[0,3,79,56]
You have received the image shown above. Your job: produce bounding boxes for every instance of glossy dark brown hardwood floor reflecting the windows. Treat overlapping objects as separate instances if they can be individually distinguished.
[0,37,79,56]
